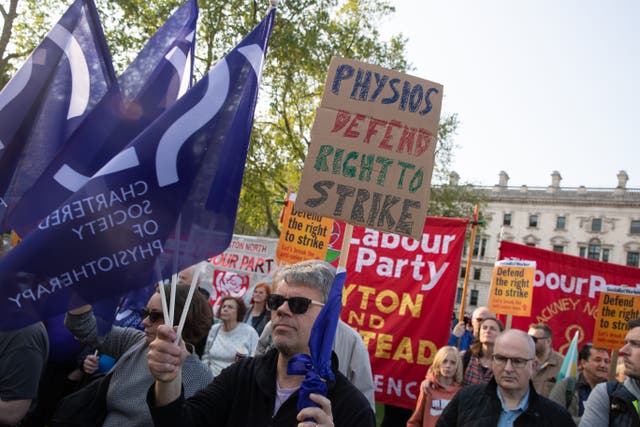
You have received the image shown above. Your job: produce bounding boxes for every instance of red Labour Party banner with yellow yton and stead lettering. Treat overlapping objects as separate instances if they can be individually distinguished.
[342,217,468,409]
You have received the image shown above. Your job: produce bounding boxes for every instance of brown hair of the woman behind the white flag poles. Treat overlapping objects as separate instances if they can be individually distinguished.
[156,285,213,345]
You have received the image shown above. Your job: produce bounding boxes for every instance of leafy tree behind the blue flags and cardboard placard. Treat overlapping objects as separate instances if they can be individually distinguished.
[0,0,480,235]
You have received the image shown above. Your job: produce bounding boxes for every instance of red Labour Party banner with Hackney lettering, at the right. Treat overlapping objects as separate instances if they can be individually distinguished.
[500,241,640,354]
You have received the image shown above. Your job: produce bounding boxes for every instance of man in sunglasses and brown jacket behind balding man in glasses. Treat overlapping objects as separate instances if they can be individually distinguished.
[529,323,564,397]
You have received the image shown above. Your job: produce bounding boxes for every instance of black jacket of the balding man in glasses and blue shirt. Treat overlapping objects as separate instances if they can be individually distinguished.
[436,378,576,427]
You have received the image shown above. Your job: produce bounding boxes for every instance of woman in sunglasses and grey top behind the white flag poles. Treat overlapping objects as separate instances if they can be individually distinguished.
[65,285,213,427]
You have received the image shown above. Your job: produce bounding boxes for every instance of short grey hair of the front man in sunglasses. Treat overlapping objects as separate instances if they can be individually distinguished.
[276,259,336,303]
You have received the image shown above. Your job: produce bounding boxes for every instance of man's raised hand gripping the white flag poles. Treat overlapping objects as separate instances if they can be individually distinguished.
[147,325,187,383]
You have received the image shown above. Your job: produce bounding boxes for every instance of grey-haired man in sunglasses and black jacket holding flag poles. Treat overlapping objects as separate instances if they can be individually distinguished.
[147,261,375,427]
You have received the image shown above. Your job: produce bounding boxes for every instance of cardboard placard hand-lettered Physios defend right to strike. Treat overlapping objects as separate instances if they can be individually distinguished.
[295,57,442,239]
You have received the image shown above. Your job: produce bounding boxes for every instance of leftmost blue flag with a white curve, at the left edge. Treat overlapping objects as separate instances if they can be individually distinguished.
[0,0,115,231]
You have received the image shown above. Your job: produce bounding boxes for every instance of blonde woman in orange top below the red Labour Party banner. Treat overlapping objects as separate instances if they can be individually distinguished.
[407,346,462,427]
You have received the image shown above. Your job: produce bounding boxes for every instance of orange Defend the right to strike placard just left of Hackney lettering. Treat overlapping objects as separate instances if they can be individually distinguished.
[489,260,536,316]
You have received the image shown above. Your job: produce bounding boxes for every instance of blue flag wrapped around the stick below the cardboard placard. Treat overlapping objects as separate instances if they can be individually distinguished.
[287,268,347,411]
